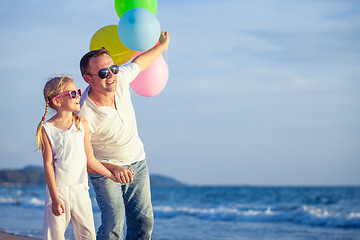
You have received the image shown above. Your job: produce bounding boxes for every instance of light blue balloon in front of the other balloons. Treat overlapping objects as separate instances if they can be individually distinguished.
[118,8,161,51]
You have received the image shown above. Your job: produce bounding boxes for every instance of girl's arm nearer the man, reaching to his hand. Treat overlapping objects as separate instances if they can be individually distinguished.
[81,118,118,182]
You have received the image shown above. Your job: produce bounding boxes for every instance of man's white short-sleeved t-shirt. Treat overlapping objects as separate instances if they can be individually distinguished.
[79,63,145,166]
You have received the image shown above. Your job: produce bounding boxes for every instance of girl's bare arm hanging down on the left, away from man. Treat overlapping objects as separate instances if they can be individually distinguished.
[41,128,65,216]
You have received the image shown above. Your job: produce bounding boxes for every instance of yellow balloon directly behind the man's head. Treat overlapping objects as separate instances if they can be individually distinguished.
[90,25,136,65]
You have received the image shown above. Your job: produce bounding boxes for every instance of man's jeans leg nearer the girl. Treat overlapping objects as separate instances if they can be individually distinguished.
[89,174,125,240]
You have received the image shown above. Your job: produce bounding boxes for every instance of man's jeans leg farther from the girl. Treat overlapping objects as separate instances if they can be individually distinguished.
[123,160,154,240]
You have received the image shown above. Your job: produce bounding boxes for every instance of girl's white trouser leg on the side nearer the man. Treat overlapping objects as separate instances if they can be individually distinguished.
[70,185,96,240]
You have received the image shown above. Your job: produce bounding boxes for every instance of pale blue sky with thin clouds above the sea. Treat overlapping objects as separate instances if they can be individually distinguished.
[0,0,360,186]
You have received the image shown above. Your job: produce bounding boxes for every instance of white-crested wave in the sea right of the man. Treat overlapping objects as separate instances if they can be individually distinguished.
[154,205,360,228]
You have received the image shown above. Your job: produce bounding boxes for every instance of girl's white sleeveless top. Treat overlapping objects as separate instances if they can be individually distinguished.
[43,122,88,187]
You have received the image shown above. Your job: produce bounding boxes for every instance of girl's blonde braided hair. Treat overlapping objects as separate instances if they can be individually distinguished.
[36,75,81,151]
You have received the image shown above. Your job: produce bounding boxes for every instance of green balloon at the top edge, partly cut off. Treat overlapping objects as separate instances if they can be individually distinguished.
[115,0,157,18]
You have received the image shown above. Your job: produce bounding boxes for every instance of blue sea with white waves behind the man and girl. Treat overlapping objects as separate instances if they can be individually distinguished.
[0,186,360,240]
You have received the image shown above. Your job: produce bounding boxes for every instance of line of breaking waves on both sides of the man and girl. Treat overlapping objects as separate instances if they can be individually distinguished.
[0,192,360,229]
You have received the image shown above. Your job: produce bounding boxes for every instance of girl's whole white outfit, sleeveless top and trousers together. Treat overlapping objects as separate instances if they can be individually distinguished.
[43,122,96,240]
